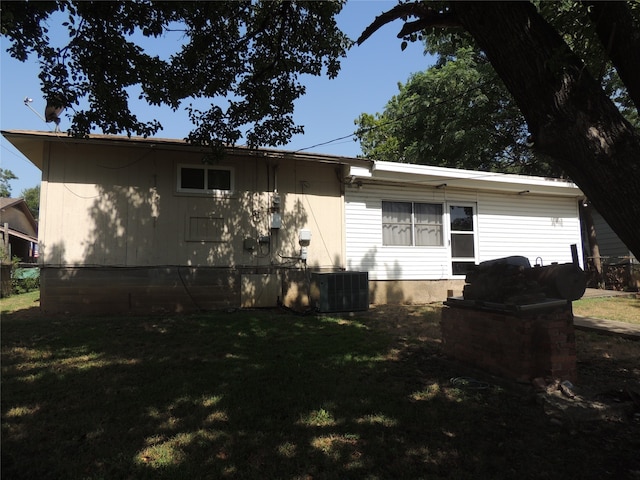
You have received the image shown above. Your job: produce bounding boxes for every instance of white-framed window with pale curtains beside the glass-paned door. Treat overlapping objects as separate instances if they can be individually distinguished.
[382,201,443,247]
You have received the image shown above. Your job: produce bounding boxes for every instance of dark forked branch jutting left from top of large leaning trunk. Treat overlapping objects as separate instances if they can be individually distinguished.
[356,3,462,45]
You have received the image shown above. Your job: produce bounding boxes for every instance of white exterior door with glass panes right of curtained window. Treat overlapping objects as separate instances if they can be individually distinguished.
[447,203,478,276]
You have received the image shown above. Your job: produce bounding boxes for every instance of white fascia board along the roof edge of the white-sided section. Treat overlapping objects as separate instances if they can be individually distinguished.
[351,161,584,197]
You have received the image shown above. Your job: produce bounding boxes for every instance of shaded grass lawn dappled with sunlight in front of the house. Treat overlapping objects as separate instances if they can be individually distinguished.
[2,311,640,479]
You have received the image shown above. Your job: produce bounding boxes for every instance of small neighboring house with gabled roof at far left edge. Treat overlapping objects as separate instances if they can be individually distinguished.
[0,198,38,263]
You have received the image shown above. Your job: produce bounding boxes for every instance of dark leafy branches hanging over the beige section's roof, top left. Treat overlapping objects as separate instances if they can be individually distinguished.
[2,0,350,146]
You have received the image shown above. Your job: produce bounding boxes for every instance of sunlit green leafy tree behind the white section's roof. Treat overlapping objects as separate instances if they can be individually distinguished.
[356,46,561,176]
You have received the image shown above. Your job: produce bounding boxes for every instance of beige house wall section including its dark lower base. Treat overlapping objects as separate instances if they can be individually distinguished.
[30,139,344,312]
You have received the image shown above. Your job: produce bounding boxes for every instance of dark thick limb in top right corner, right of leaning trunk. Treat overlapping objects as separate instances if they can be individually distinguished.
[584,1,640,112]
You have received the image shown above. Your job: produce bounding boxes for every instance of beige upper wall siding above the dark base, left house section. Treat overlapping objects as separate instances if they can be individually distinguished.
[41,141,343,267]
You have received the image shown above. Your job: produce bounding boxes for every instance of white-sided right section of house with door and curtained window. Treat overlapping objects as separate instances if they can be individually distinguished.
[345,162,584,303]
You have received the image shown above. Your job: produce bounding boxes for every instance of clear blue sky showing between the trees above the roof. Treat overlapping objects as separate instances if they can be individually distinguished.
[0,0,433,197]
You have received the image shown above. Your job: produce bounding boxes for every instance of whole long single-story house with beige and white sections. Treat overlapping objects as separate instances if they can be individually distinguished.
[2,131,583,312]
